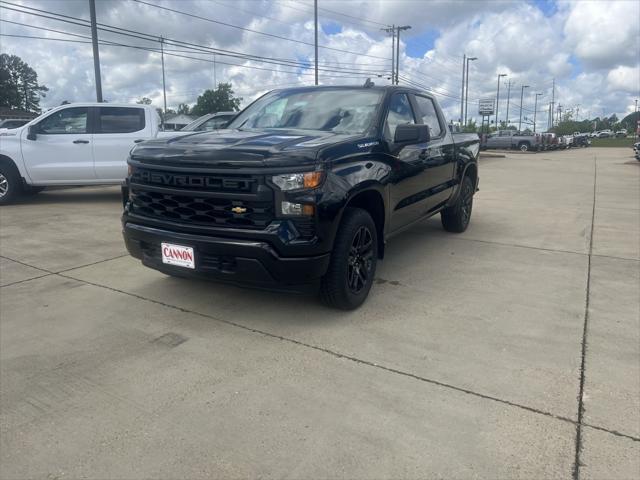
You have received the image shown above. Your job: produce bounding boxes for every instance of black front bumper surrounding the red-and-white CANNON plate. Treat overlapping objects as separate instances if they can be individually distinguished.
[123,221,330,292]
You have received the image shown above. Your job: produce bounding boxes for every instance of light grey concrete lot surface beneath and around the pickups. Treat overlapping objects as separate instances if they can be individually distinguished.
[0,148,640,479]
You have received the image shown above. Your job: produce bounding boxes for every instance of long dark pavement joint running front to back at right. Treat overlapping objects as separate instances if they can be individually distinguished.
[572,155,598,480]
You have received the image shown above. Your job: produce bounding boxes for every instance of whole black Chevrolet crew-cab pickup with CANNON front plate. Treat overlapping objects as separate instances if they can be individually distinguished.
[122,83,480,309]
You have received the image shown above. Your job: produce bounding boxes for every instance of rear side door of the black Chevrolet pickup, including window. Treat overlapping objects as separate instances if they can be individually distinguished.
[413,94,456,213]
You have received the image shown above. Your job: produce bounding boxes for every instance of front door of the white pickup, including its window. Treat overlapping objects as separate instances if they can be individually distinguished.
[21,107,96,185]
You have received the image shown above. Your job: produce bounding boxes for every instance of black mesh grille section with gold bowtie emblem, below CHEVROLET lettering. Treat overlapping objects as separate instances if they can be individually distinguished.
[130,185,274,229]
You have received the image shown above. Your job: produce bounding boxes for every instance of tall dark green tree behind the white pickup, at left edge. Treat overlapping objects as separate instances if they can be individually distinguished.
[0,53,49,112]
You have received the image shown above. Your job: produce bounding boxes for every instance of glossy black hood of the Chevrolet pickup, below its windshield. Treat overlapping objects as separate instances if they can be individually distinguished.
[131,129,368,168]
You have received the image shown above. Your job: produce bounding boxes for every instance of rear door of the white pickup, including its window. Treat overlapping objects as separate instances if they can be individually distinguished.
[93,106,151,183]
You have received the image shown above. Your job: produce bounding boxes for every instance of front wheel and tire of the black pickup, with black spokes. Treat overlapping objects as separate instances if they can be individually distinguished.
[320,208,378,310]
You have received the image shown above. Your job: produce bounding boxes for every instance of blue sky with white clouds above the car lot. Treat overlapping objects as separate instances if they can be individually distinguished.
[0,0,640,131]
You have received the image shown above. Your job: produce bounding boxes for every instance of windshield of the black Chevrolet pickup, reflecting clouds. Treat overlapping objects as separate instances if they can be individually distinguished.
[229,88,382,134]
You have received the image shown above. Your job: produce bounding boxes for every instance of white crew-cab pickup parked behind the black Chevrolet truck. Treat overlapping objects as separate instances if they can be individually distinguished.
[0,103,188,205]
